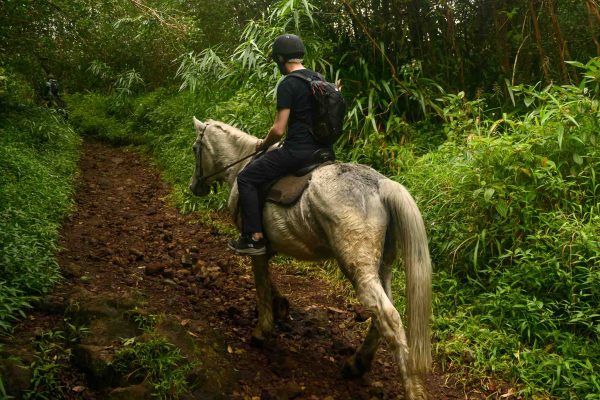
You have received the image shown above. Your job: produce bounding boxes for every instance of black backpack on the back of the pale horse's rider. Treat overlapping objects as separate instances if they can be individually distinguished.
[287,72,346,144]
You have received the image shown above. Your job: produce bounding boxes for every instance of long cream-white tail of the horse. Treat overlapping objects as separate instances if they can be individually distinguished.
[379,179,431,373]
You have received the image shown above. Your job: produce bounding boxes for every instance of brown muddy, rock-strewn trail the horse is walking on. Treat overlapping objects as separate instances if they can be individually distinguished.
[1,142,496,400]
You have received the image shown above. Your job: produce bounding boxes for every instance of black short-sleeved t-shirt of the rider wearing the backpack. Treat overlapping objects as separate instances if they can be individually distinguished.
[277,69,327,150]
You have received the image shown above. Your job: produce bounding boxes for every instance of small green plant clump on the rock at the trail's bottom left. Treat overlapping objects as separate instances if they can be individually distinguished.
[113,336,195,399]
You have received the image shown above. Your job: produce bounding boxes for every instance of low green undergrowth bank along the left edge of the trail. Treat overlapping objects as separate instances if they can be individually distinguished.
[0,97,79,329]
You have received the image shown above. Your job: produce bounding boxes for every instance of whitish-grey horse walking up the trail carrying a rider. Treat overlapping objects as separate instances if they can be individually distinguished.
[189,117,432,400]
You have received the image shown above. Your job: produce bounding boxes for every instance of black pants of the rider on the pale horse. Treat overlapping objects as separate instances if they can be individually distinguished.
[237,147,316,235]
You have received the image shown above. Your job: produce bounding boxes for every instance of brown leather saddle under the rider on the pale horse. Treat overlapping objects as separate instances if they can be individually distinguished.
[259,149,335,206]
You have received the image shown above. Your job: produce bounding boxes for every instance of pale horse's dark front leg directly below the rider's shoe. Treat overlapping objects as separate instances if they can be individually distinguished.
[252,255,278,344]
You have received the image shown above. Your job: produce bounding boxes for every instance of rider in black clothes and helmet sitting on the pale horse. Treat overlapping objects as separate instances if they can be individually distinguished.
[229,34,331,255]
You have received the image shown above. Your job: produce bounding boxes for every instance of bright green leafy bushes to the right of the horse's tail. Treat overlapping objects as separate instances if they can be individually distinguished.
[398,69,600,398]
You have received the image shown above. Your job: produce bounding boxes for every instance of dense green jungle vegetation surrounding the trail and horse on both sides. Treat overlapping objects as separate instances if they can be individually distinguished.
[0,0,600,399]
